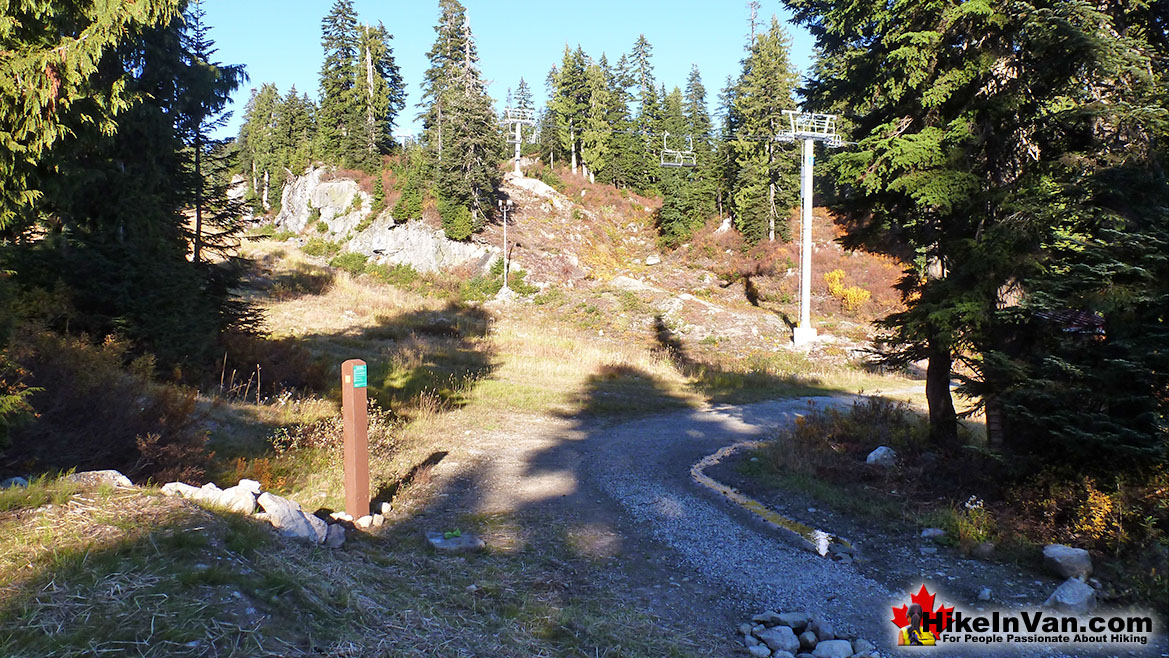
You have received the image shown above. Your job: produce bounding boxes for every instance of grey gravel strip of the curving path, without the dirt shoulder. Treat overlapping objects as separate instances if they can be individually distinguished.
[585,399,897,642]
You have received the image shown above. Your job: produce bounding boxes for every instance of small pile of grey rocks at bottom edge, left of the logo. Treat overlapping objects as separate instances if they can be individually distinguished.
[739,610,880,658]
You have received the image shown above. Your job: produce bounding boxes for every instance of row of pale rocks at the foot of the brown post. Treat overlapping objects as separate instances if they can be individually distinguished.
[162,479,389,548]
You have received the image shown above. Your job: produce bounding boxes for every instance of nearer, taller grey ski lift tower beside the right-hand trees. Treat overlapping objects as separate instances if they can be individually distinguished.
[776,110,844,345]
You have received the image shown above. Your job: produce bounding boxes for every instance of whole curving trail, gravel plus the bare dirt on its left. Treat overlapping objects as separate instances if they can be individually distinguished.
[416,397,1155,656]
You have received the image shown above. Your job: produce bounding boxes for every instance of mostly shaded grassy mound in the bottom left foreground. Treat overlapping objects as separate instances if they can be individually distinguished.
[0,483,713,657]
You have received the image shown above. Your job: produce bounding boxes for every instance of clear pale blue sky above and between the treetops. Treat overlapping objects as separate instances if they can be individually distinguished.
[203,0,812,137]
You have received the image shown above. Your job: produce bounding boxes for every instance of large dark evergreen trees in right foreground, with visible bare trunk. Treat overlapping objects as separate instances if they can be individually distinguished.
[789,0,1169,458]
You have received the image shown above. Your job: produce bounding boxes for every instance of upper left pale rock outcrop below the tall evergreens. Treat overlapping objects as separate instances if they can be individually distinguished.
[275,167,373,235]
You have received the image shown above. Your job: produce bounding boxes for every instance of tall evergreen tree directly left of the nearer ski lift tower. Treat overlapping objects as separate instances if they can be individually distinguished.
[731,16,798,243]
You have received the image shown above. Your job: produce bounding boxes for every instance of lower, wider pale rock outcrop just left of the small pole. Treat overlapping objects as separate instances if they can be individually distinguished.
[347,214,499,272]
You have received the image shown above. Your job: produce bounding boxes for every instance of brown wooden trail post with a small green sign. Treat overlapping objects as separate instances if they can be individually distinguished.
[341,359,369,519]
